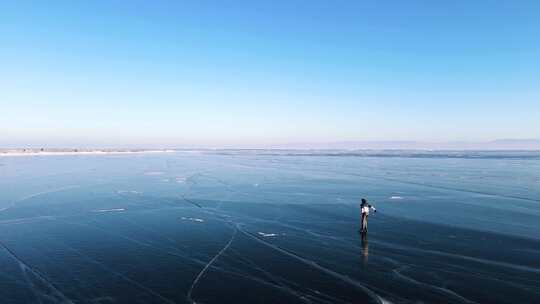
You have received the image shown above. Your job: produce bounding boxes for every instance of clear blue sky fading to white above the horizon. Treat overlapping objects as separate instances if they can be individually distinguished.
[0,0,540,146]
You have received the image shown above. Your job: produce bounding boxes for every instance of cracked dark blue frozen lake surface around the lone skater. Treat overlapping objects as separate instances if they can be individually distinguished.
[0,151,540,304]
